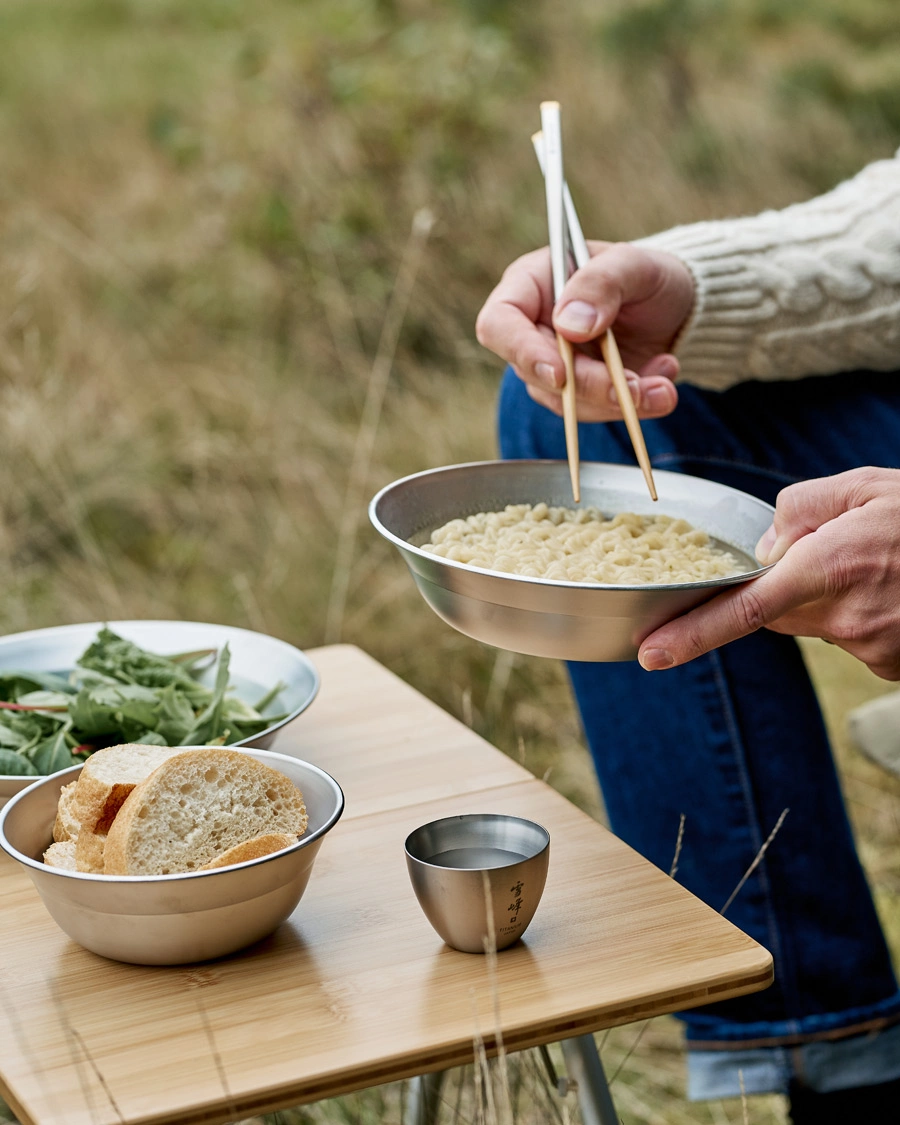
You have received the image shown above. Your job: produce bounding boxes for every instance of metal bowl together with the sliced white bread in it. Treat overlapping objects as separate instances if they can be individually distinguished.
[0,745,344,965]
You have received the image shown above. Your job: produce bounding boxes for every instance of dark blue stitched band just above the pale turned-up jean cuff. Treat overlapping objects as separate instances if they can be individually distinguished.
[682,992,900,1054]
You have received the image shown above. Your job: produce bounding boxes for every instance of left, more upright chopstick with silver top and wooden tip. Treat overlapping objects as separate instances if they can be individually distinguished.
[541,101,582,504]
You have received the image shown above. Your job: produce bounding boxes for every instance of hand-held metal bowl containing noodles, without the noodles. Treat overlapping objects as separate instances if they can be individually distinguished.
[369,461,774,660]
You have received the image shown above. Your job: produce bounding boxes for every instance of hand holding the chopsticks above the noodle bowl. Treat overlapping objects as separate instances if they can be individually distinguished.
[475,242,694,422]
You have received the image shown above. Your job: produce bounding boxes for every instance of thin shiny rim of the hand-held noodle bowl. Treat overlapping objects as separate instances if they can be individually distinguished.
[369,458,775,593]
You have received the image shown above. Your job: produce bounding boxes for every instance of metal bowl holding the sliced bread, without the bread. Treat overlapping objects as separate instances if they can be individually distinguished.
[0,749,344,965]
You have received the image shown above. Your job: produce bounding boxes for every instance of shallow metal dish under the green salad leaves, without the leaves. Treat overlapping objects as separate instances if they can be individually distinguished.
[0,621,318,807]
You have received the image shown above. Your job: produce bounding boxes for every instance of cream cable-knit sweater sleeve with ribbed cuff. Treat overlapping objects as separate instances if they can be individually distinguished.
[638,152,900,390]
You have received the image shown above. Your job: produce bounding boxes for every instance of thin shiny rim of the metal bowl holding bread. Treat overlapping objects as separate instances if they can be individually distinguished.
[0,746,345,887]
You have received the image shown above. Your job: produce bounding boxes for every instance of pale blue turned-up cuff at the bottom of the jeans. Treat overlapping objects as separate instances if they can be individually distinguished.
[687,1024,900,1101]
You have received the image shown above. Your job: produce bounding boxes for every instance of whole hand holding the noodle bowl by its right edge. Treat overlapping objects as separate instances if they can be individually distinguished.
[638,468,900,680]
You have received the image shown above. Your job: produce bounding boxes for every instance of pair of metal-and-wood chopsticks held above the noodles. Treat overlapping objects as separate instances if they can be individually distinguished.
[531,101,657,504]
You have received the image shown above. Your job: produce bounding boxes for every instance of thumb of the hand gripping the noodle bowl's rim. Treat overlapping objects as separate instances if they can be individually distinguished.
[756,469,876,566]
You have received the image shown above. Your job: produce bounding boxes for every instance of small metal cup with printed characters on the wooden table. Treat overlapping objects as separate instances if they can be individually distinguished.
[406,812,550,953]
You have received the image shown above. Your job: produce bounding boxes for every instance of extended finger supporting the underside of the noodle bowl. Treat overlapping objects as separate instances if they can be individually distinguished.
[638,545,828,672]
